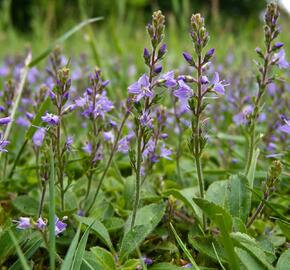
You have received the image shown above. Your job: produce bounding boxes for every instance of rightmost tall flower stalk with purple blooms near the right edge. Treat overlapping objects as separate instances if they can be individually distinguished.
[245,3,289,175]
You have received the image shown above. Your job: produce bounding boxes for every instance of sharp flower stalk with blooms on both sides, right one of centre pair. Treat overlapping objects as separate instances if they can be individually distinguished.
[173,14,226,229]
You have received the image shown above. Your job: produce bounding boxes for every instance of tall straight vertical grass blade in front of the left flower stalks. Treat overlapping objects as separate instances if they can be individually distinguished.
[48,147,56,270]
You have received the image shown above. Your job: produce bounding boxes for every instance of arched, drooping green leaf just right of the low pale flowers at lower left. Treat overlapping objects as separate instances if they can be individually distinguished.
[75,216,114,251]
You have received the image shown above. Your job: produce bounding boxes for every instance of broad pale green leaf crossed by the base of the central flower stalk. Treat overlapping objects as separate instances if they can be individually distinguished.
[125,203,165,234]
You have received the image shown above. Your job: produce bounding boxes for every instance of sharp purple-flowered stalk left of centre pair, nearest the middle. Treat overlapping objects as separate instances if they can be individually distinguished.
[128,11,176,228]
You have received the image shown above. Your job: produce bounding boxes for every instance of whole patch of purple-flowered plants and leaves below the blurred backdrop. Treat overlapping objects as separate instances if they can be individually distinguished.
[0,3,290,270]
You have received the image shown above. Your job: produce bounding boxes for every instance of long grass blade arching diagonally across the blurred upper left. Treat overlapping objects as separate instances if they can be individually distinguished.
[28,17,103,68]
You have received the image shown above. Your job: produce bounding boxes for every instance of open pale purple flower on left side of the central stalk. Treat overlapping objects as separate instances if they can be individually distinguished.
[128,74,153,102]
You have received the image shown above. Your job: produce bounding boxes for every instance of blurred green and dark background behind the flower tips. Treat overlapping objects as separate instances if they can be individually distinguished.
[0,0,290,65]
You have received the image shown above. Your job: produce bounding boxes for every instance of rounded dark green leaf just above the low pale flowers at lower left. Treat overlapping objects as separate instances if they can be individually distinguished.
[12,195,38,216]
